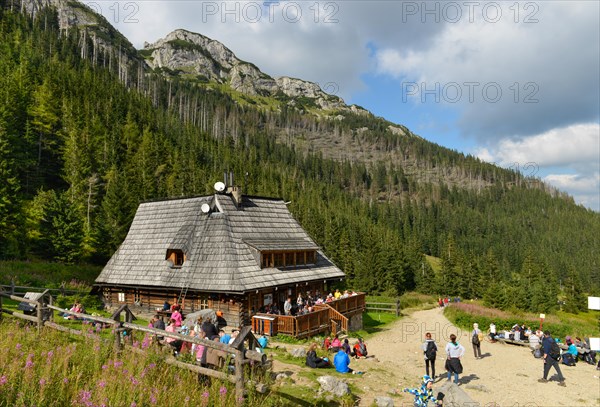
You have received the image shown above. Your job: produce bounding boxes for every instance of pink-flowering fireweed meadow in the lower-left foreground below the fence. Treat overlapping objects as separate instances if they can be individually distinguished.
[0,319,268,407]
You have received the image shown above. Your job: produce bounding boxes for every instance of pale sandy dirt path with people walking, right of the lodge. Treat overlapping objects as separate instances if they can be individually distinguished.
[276,308,600,407]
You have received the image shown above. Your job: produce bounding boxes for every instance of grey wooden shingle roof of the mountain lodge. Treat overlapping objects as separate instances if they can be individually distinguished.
[96,194,344,293]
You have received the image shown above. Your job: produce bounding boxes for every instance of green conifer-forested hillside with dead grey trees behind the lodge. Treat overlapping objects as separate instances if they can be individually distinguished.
[0,3,600,311]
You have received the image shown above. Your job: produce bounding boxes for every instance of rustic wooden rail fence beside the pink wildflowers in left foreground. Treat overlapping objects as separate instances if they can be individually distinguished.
[0,291,267,399]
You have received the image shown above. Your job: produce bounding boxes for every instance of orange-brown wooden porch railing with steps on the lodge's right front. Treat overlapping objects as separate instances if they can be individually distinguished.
[252,293,365,338]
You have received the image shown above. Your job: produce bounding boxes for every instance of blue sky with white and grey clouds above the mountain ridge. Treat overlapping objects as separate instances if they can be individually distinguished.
[92,0,600,211]
